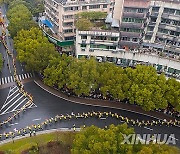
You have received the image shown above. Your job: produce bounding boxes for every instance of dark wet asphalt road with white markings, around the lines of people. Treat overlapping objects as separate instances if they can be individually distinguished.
[0,3,180,146]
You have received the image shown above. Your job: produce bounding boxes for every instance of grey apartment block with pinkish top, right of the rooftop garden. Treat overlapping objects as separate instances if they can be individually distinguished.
[119,0,150,50]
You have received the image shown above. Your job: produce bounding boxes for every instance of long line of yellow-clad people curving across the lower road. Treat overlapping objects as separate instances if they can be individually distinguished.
[0,111,180,140]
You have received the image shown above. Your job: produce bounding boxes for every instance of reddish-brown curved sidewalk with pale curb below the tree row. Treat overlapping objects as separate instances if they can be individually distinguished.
[34,79,175,120]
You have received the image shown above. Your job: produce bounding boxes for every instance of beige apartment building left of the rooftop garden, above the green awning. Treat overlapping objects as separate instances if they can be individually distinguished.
[44,0,114,40]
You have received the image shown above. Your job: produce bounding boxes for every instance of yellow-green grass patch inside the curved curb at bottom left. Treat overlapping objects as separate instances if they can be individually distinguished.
[0,132,75,154]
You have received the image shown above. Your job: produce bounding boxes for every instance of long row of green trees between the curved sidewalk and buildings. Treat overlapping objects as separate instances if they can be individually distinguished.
[8,0,180,111]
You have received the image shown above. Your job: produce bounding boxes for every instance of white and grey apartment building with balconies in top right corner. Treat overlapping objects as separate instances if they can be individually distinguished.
[142,0,180,56]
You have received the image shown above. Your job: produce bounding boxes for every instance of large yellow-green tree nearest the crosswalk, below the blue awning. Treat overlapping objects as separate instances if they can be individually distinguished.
[14,28,58,72]
